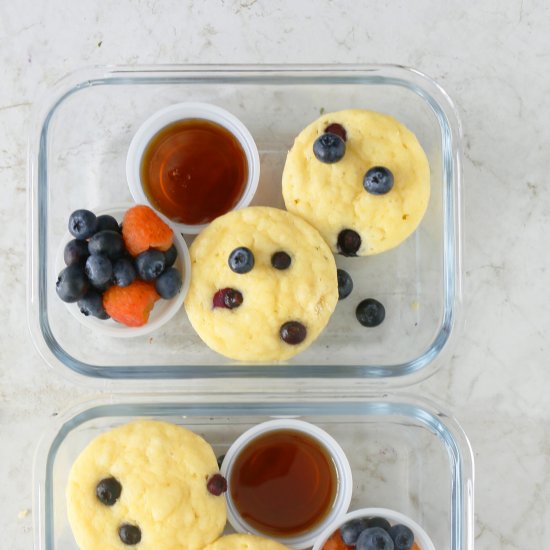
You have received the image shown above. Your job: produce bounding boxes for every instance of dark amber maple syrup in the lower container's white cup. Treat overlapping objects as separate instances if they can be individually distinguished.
[229,429,338,536]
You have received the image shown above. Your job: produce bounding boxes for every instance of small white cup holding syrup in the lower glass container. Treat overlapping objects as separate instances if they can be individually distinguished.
[220,418,353,550]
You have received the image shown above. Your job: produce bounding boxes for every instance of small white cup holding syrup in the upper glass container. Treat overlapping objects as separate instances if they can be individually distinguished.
[126,102,260,235]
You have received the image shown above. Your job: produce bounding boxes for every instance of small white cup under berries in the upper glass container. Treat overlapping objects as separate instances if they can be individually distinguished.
[53,204,191,338]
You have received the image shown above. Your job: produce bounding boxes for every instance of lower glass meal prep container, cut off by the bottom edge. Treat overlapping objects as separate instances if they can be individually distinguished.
[34,393,473,550]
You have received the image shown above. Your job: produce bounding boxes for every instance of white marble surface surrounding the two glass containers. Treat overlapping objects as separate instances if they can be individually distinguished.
[0,0,550,550]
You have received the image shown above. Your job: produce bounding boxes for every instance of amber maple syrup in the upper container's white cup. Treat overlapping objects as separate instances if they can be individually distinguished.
[140,119,248,225]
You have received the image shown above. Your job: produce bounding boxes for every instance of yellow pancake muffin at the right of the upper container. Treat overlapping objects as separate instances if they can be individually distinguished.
[283,109,430,256]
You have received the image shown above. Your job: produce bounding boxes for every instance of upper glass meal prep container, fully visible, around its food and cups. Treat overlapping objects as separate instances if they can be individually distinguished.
[28,65,461,389]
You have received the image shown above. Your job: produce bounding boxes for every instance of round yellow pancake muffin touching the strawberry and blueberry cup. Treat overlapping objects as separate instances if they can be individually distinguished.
[185,207,338,362]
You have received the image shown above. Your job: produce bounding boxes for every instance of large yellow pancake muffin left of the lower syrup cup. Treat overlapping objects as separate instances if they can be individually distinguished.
[67,420,226,550]
